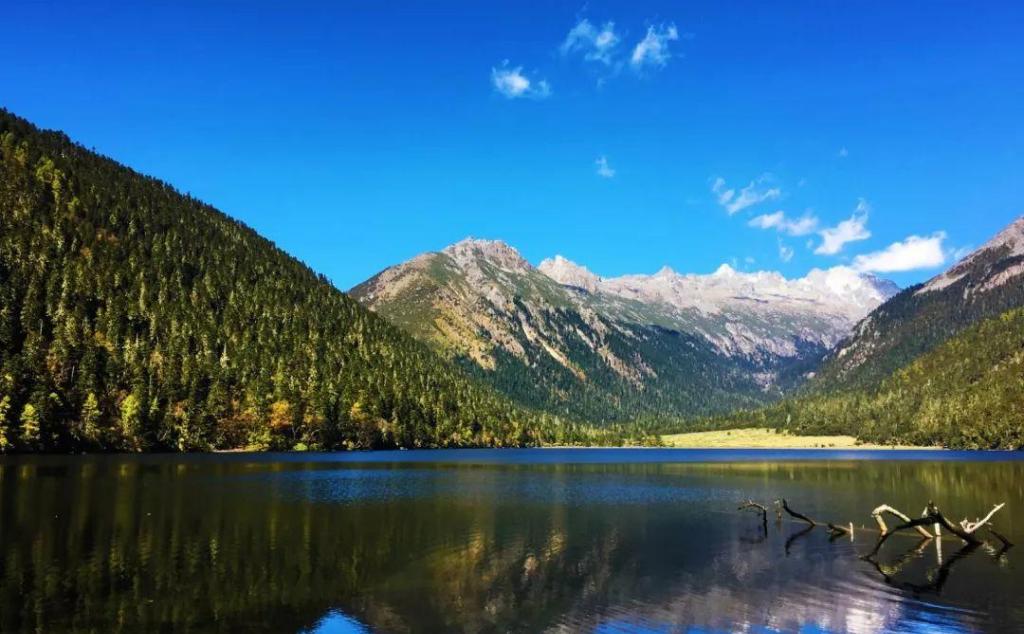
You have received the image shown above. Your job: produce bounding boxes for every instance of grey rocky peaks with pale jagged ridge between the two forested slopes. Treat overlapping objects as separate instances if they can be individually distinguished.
[350,239,896,421]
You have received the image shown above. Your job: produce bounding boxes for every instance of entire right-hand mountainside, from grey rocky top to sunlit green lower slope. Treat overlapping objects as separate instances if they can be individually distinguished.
[712,217,1024,449]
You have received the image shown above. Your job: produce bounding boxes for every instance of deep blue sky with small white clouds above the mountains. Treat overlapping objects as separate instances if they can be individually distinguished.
[0,1,1024,288]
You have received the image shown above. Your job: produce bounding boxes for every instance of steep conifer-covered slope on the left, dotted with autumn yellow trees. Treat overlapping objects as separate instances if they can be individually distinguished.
[0,111,651,451]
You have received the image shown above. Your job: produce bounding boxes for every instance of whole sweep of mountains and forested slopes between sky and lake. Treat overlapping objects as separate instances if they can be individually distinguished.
[0,105,1024,452]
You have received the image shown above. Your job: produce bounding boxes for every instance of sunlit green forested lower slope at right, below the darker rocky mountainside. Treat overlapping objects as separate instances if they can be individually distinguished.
[702,309,1024,449]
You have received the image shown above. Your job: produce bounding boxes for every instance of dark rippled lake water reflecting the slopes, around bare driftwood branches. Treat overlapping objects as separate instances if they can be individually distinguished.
[0,450,1024,633]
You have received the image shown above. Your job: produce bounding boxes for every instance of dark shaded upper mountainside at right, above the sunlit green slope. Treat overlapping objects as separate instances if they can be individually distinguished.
[810,217,1024,391]
